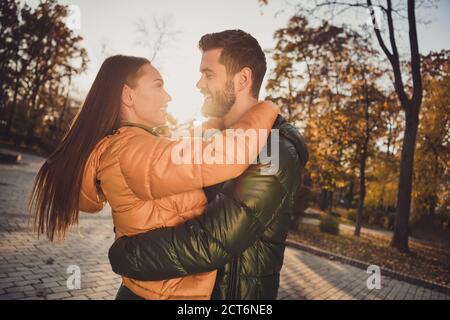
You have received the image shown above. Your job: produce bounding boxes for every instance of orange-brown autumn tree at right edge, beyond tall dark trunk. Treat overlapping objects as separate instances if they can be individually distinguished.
[413,51,450,221]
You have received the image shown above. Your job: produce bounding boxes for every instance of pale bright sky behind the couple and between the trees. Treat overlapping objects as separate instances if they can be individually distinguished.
[26,0,450,122]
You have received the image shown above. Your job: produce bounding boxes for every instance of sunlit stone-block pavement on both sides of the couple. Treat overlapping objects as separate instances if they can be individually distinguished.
[0,148,450,300]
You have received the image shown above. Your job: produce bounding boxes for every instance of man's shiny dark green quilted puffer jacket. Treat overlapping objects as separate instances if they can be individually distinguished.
[109,116,308,299]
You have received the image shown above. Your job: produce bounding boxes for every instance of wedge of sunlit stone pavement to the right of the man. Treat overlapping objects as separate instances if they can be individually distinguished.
[278,247,450,300]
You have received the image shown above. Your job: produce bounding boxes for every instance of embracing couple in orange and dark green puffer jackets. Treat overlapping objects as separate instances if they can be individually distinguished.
[31,30,308,300]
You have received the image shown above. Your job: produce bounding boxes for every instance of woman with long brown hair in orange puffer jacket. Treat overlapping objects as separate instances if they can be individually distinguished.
[30,55,278,299]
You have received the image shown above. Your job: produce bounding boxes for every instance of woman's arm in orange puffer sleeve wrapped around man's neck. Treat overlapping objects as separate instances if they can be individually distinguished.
[119,102,278,199]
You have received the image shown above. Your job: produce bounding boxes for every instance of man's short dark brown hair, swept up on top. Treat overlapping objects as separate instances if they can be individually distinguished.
[198,29,267,98]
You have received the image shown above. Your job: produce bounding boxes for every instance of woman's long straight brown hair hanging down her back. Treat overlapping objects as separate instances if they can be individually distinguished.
[29,55,150,241]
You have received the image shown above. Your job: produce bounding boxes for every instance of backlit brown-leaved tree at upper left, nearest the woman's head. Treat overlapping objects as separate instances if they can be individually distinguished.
[19,1,87,144]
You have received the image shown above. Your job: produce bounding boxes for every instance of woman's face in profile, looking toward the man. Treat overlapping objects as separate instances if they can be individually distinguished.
[122,64,172,127]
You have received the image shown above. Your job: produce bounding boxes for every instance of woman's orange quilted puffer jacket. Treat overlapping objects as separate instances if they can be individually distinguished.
[79,102,278,300]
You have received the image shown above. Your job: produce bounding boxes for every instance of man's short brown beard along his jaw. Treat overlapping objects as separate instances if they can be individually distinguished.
[202,79,236,118]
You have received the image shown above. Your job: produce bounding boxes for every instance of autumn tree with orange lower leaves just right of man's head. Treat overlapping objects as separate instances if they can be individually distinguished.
[267,15,356,212]
